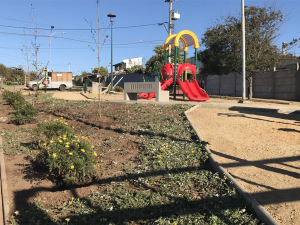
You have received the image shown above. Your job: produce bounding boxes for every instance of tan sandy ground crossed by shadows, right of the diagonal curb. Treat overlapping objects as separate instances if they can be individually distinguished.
[189,106,300,225]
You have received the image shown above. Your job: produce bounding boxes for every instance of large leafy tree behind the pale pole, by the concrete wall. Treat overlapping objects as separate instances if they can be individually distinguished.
[198,6,285,100]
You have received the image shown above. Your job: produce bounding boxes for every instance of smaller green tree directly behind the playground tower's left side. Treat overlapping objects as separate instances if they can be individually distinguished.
[146,45,183,73]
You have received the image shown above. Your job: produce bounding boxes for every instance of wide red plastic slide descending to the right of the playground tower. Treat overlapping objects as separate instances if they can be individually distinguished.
[176,78,209,102]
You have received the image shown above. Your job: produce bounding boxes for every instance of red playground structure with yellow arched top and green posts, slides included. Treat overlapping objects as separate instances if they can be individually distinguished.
[138,30,209,102]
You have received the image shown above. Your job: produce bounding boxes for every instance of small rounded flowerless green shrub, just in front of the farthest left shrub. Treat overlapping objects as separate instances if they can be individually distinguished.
[12,101,38,125]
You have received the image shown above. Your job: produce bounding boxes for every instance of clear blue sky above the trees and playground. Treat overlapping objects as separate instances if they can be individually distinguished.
[0,0,300,75]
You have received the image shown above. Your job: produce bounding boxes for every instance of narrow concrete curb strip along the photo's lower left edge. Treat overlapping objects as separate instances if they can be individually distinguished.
[0,136,9,225]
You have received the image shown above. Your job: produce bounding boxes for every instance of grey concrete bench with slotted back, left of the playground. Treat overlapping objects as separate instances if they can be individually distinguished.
[124,81,169,102]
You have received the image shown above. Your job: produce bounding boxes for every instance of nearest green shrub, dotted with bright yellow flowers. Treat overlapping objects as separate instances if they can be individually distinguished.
[37,132,100,184]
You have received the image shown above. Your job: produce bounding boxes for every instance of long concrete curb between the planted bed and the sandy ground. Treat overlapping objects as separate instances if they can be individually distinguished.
[184,105,279,225]
